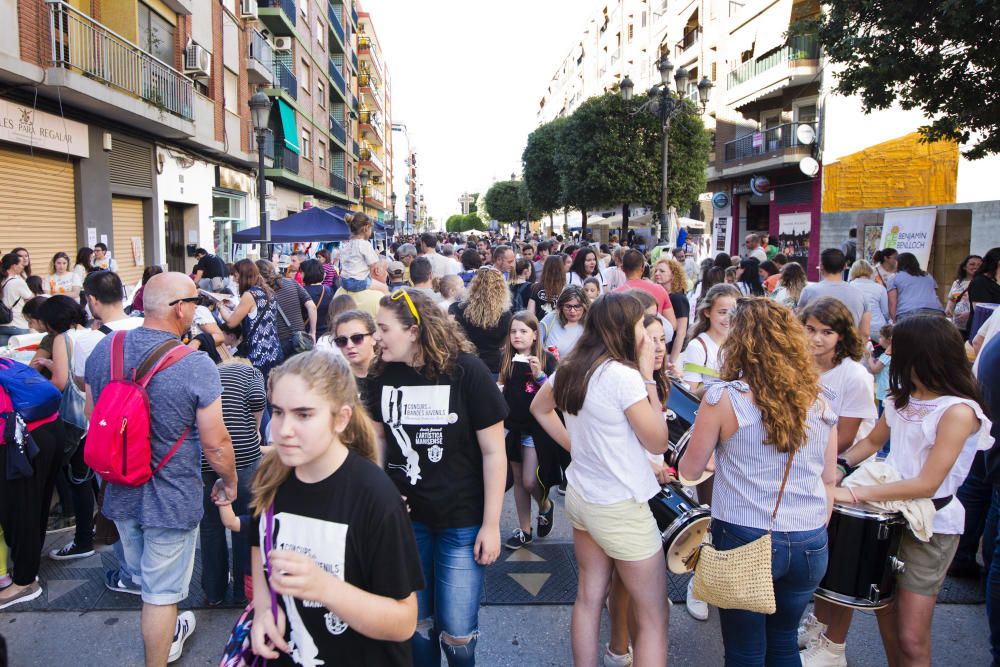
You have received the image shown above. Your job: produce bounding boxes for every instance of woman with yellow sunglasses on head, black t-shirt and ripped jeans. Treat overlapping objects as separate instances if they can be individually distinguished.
[365,288,507,667]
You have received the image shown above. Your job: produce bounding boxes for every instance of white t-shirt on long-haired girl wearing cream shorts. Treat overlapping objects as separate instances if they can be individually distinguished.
[564,361,660,505]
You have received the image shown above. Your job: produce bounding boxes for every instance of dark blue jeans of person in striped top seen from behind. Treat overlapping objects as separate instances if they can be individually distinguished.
[200,461,259,602]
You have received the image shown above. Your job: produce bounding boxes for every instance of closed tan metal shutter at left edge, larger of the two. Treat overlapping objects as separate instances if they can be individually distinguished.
[0,148,78,268]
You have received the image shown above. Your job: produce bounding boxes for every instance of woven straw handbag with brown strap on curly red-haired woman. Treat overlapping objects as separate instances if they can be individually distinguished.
[692,452,795,614]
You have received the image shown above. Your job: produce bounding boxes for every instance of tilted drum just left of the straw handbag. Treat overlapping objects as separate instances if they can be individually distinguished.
[649,482,712,574]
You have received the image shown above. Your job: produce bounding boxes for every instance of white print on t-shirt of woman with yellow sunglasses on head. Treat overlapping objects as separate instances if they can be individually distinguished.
[382,385,457,486]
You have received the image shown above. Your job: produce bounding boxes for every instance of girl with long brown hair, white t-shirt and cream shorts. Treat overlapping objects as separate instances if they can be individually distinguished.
[531,293,668,667]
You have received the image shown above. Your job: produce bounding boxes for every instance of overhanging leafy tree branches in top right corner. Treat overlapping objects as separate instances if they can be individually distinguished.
[812,0,1000,160]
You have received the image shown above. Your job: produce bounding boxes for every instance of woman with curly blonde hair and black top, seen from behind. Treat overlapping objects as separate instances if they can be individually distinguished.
[448,267,511,377]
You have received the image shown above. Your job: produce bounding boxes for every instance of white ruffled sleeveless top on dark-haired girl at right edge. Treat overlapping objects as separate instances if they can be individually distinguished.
[885,396,993,535]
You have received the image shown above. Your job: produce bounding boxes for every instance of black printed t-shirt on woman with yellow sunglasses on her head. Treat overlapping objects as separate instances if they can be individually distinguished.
[366,353,507,529]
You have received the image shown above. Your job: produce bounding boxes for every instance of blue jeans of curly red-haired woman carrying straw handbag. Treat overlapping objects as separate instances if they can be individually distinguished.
[712,519,829,667]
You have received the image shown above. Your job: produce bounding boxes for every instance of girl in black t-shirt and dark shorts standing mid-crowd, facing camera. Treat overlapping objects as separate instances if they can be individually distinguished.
[499,310,559,549]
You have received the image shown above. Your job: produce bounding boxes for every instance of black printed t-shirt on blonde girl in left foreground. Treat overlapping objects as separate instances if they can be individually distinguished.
[248,452,424,667]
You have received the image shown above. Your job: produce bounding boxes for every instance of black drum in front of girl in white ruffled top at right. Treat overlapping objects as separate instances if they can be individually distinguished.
[816,505,906,609]
